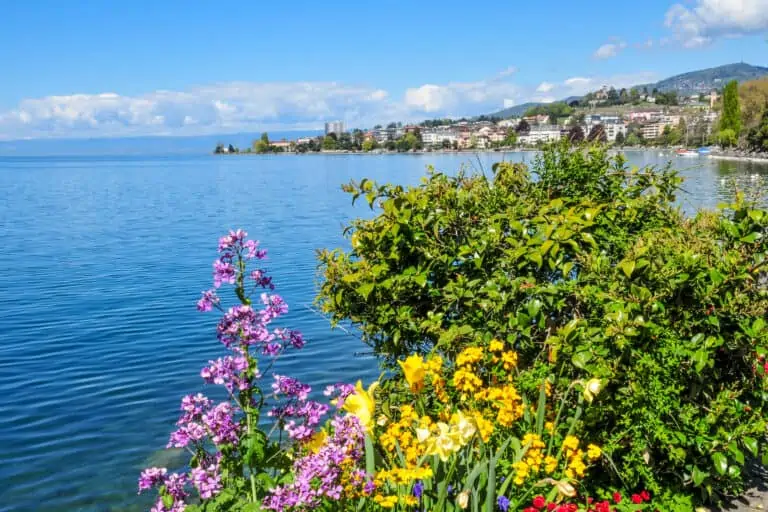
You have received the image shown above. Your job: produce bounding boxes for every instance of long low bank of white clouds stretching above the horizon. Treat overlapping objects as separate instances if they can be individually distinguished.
[0,69,657,139]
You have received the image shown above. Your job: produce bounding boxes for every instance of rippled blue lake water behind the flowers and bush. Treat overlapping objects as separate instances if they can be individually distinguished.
[0,153,768,511]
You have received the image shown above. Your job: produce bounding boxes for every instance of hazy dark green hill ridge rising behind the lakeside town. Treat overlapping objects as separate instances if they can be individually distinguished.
[488,62,768,118]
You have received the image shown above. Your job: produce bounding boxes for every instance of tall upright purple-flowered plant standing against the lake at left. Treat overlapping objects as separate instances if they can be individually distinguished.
[139,230,314,512]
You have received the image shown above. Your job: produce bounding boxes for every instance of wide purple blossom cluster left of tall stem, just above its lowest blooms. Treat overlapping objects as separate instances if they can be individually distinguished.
[167,393,240,448]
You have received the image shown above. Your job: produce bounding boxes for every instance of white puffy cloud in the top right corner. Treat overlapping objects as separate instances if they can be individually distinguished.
[665,0,768,48]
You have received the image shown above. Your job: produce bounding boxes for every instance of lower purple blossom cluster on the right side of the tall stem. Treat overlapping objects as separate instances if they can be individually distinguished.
[267,375,328,441]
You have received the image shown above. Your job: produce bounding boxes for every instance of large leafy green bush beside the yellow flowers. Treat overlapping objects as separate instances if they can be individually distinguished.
[319,145,768,499]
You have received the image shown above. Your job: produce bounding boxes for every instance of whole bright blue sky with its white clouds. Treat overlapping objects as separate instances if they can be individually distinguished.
[0,0,768,139]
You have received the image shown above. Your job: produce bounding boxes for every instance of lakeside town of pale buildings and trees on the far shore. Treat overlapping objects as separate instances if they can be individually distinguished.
[214,77,763,154]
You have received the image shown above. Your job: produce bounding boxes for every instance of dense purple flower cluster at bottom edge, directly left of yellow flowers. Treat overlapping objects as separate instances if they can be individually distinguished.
[262,415,372,512]
